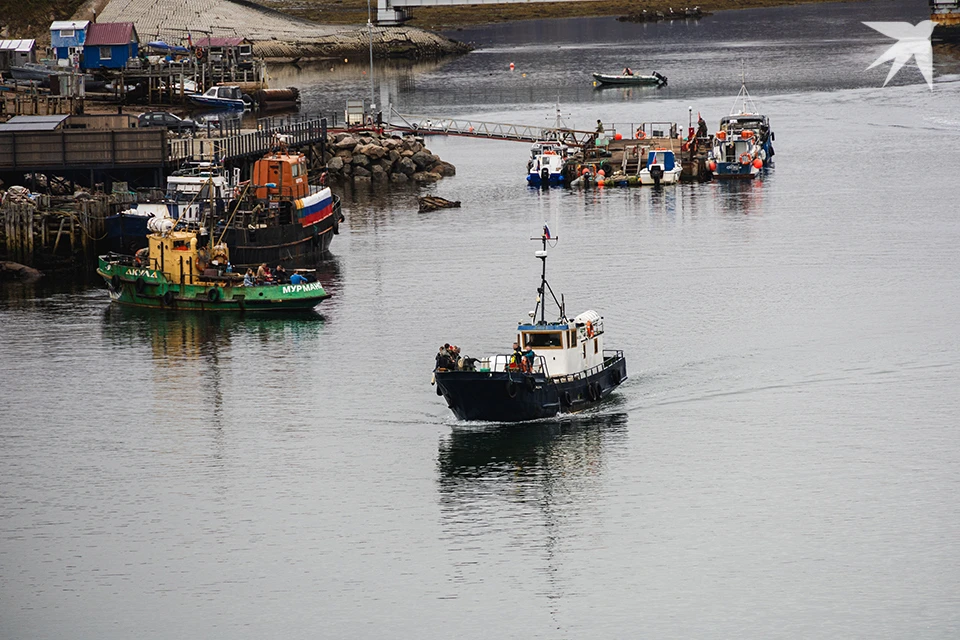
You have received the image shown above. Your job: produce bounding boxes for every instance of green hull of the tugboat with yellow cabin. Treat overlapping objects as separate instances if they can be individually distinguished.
[97,256,330,313]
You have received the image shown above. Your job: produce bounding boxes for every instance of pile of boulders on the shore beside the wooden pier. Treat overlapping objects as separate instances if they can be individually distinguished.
[324,132,457,184]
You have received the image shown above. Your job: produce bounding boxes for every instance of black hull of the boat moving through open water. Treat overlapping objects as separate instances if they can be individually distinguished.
[434,356,627,422]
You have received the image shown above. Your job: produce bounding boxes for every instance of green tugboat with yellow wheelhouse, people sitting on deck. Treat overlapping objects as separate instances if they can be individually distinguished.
[97,220,330,312]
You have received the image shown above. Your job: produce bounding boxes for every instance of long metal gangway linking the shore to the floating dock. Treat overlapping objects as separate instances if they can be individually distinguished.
[386,111,597,147]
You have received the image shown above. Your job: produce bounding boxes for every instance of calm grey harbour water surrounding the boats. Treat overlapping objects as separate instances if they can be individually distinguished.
[0,3,960,638]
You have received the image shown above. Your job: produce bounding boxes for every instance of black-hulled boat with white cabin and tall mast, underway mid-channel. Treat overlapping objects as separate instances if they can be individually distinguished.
[434,227,627,422]
